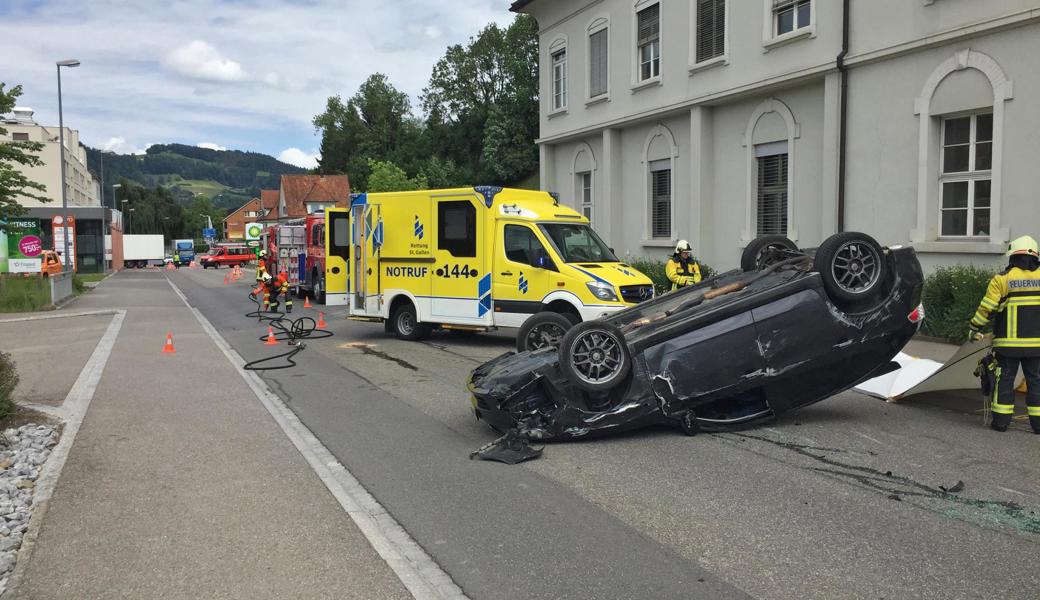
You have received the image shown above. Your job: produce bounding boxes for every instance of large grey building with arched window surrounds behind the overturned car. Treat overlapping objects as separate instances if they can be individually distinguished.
[512,0,1040,269]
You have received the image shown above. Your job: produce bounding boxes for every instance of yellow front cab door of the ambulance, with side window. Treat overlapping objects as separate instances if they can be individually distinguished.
[492,221,549,328]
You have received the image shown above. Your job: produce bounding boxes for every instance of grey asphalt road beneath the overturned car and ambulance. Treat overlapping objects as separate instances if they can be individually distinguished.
[168,269,1040,599]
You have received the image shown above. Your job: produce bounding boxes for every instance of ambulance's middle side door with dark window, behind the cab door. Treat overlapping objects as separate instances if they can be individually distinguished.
[430,197,492,324]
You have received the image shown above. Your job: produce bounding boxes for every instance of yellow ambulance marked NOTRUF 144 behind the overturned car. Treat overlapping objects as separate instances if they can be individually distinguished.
[349,186,653,350]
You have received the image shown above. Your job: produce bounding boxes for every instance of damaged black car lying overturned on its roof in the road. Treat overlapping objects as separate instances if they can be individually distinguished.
[469,233,924,447]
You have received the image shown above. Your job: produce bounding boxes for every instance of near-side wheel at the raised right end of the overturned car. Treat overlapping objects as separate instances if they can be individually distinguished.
[812,231,888,305]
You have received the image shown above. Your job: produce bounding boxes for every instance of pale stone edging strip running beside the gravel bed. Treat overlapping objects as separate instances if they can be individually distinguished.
[7,310,127,590]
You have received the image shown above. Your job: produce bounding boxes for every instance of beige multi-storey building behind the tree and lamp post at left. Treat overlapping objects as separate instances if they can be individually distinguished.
[0,108,101,208]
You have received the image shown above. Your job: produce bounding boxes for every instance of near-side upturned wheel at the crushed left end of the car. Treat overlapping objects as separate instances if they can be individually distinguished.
[560,320,632,392]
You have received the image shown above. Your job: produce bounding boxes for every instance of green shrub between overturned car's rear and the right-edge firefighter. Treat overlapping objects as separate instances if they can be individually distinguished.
[921,265,994,344]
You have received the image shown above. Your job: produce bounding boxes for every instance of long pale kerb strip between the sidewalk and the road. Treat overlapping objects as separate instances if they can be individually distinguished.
[166,278,468,600]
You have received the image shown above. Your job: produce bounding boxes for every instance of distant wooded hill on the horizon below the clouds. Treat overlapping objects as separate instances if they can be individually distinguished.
[86,144,307,209]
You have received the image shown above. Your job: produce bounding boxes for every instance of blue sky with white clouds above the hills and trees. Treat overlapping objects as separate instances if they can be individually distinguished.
[0,0,513,166]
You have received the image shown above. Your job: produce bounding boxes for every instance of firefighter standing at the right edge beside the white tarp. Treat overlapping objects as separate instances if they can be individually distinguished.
[968,235,1040,434]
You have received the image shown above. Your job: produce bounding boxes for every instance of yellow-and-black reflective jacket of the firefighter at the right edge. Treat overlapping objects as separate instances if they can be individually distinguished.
[971,267,1040,356]
